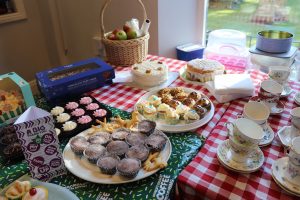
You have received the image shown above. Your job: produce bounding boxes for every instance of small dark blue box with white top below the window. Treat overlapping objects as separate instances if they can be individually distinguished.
[176,43,204,61]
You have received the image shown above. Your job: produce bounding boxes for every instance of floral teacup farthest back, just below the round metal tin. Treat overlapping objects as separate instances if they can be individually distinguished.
[269,66,291,85]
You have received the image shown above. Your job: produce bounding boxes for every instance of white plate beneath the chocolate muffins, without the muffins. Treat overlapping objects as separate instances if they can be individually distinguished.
[63,129,172,184]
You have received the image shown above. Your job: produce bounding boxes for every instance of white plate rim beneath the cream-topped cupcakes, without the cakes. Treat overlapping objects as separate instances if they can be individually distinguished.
[134,88,215,133]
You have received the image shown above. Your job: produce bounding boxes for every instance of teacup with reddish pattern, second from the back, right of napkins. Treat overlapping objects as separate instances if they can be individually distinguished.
[258,80,283,103]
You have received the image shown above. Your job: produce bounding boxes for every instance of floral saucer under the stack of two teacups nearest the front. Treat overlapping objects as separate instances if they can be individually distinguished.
[217,139,264,173]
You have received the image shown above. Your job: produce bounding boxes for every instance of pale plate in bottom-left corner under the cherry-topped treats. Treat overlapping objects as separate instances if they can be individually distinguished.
[0,175,79,200]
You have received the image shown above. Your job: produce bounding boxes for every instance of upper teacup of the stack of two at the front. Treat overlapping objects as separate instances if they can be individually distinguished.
[225,118,264,147]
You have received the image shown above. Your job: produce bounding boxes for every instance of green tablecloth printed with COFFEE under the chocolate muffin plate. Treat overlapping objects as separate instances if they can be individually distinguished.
[0,102,204,200]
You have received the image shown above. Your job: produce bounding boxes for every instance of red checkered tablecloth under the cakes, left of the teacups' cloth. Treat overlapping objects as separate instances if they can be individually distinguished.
[91,55,229,137]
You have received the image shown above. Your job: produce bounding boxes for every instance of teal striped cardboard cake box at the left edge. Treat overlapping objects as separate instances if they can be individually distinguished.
[0,72,35,127]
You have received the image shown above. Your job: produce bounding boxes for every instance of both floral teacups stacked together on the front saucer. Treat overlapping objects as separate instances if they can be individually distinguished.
[226,118,263,163]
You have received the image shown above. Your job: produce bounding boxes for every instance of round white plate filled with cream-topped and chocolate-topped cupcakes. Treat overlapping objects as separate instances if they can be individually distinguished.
[135,87,215,133]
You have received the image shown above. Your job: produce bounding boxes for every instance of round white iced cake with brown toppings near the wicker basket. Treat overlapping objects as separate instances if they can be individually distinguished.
[131,60,169,86]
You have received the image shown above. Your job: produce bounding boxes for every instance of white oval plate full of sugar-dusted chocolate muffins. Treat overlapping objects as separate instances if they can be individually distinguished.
[63,120,172,184]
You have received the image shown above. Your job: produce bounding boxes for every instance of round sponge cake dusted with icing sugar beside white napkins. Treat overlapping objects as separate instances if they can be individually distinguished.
[186,59,225,82]
